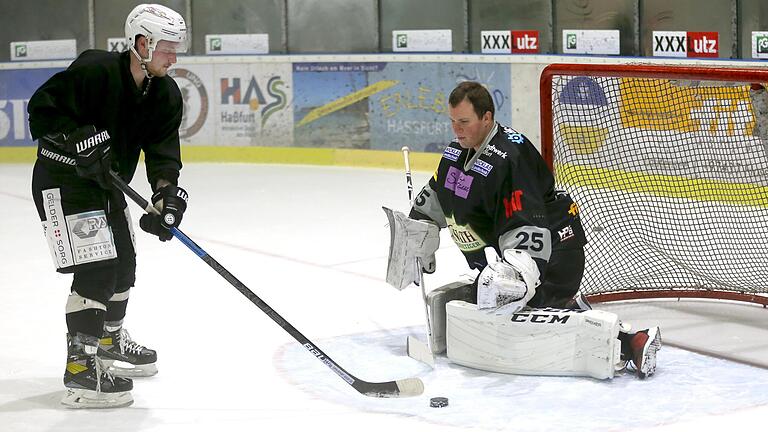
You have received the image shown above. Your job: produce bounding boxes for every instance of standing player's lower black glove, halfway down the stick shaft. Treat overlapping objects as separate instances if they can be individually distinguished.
[139,185,189,241]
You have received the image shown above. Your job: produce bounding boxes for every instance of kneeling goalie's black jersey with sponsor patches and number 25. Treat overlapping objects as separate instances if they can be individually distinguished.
[411,123,586,275]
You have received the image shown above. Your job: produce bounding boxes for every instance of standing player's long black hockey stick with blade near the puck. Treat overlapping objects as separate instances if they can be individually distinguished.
[110,171,424,397]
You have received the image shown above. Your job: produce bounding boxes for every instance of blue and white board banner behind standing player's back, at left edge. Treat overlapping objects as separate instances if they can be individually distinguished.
[0,68,63,146]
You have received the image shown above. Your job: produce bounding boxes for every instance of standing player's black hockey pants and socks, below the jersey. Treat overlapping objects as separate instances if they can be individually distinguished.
[32,160,136,337]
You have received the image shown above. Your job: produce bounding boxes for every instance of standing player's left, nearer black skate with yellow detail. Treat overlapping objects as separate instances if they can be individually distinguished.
[61,334,133,408]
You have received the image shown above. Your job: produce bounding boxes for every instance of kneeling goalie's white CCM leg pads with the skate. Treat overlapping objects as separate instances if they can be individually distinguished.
[428,281,661,379]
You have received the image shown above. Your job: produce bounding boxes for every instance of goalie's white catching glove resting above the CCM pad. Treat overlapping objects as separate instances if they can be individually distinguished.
[477,247,541,314]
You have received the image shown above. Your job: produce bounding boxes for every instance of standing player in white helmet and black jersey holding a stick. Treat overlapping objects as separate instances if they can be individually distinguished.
[28,4,187,408]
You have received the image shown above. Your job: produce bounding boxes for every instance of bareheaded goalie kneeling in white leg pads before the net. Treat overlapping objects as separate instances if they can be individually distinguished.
[388,82,661,378]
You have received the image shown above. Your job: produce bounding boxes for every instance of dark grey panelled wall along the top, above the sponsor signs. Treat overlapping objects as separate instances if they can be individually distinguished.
[0,0,768,61]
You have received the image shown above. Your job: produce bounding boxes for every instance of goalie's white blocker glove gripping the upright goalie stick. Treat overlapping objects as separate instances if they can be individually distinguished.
[382,207,440,290]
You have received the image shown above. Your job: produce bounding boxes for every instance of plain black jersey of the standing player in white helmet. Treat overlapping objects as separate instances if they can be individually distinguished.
[27,50,182,189]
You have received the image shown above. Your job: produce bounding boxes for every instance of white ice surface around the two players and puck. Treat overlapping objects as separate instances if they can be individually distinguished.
[0,164,768,432]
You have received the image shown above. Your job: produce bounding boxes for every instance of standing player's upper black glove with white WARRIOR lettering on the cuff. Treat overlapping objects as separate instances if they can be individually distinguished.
[65,125,112,189]
